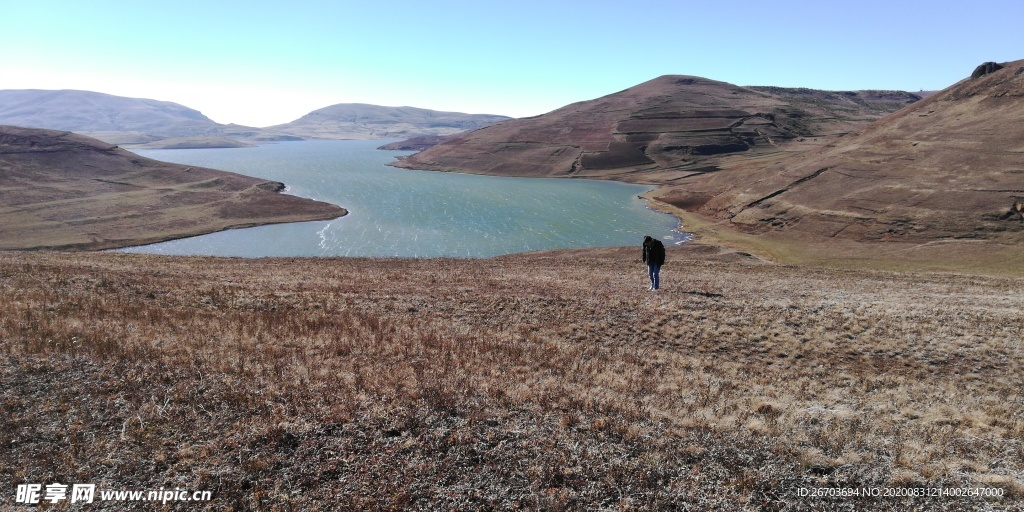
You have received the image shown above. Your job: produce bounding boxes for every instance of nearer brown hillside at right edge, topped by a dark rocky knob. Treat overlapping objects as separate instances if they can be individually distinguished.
[653,60,1024,268]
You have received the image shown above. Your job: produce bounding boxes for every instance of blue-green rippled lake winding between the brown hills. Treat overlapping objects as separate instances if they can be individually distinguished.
[120,140,687,257]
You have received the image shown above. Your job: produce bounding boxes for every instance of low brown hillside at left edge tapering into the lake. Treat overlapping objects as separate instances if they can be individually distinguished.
[0,126,346,250]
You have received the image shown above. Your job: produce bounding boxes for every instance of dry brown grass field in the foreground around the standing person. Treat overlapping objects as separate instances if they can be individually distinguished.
[0,246,1024,511]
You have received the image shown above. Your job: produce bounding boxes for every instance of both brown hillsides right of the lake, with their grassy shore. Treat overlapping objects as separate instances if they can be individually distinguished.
[395,61,1024,273]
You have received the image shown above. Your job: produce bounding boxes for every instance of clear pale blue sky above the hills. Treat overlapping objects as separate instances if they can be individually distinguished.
[0,0,1024,127]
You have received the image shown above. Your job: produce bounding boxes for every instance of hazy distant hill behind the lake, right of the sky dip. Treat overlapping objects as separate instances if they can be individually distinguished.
[269,103,510,139]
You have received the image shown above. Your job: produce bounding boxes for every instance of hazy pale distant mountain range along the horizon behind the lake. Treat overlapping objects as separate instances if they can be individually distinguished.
[0,90,509,147]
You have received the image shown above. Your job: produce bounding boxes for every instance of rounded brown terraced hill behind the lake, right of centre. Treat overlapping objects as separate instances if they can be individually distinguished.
[397,76,920,183]
